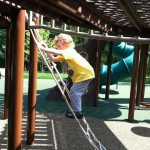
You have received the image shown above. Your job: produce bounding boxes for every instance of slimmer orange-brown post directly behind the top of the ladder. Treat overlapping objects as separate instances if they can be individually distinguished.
[26,16,38,145]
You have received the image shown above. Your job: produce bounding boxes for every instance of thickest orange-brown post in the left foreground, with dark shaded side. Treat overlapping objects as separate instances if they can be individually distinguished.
[8,9,25,150]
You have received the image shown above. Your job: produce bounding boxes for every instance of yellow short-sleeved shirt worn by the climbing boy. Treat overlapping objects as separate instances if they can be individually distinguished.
[56,49,95,83]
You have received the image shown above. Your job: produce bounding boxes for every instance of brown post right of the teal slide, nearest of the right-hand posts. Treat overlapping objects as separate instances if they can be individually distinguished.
[128,44,140,122]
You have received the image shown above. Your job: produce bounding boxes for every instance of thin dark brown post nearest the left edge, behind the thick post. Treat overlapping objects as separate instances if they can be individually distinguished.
[4,29,10,119]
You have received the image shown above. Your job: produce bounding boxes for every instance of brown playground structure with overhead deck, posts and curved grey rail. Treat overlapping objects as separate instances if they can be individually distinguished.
[0,0,150,150]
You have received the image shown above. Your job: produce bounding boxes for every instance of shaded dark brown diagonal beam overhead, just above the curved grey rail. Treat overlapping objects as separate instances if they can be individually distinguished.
[6,0,106,30]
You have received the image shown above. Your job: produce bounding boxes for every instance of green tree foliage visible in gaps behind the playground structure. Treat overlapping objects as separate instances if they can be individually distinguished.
[0,23,150,77]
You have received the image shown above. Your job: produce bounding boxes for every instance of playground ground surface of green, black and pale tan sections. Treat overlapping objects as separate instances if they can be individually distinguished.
[0,79,150,150]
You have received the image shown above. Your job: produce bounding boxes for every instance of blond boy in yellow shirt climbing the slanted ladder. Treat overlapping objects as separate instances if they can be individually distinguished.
[40,33,95,119]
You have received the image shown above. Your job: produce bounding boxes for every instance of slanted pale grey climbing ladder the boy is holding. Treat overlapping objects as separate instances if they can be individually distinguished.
[30,29,106,150]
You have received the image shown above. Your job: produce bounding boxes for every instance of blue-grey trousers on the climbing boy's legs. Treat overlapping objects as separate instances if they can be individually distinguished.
[70,79,91,112]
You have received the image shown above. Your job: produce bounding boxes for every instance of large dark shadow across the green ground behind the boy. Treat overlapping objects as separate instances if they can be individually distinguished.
[24,86,128,120]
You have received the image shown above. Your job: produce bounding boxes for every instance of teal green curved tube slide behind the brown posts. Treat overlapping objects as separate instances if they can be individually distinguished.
[100,42,134,86]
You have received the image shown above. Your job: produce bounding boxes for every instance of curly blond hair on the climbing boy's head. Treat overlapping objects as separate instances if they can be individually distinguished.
[54,33,75,48]
